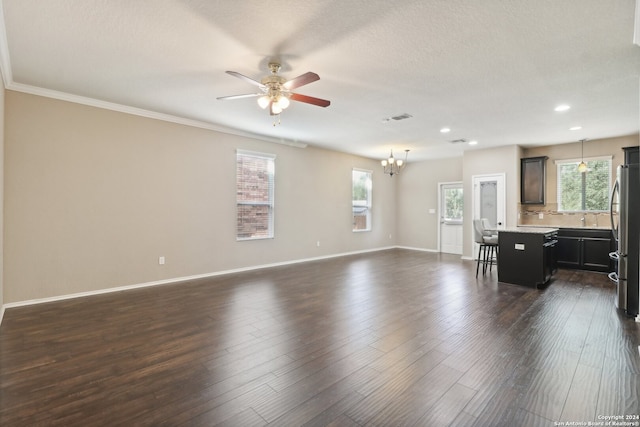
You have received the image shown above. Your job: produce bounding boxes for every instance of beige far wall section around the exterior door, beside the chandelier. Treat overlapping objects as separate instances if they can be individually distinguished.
[393,157,462,251]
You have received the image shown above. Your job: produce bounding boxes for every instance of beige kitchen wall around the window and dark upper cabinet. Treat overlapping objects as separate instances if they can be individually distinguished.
[519,134,639,227]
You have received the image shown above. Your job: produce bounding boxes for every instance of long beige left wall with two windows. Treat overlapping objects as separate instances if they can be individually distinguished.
[4,91,396,304]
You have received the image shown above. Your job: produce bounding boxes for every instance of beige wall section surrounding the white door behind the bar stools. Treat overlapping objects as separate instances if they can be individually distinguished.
[463,145,522,257]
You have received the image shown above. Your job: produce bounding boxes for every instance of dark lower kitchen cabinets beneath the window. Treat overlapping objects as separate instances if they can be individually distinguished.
[556,228,615,272]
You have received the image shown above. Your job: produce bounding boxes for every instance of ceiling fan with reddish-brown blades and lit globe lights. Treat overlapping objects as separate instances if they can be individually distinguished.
[217,62,331,116]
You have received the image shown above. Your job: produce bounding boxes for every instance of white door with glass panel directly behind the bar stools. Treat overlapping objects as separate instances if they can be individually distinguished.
[471,173,506,256]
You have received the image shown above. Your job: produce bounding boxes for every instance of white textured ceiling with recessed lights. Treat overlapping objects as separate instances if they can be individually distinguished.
[0,0,640,161]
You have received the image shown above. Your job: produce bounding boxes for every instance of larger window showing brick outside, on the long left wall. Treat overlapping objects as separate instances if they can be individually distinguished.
[236,150,275,240]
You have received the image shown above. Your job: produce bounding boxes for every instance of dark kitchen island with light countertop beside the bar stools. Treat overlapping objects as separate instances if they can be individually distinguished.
[497,227,558,288]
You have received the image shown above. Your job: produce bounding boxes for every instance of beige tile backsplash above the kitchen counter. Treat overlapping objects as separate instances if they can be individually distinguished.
[518,203,617,229]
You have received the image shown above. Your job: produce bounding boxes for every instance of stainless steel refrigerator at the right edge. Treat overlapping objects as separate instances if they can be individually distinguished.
[609,164,640,316]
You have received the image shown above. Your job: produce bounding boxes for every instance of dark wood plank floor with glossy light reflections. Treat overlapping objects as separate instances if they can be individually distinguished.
[0,249,640,427]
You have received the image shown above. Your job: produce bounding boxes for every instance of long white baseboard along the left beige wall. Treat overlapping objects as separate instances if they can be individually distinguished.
[0,246,399,310]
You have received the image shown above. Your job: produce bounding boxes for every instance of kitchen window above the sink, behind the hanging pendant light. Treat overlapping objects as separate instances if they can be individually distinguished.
[556,157,611,212]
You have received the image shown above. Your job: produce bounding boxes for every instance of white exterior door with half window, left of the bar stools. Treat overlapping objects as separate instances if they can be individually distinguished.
[438,182,464,255]
